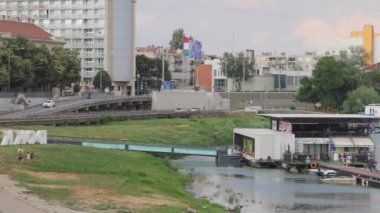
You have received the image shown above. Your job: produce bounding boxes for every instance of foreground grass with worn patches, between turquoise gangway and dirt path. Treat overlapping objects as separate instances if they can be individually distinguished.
[0,145,223,212]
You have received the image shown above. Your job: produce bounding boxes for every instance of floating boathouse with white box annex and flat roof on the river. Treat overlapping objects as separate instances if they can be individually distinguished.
[233,114,380,162]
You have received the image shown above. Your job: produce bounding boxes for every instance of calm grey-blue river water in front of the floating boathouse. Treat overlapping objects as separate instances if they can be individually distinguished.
[173,156,380,213]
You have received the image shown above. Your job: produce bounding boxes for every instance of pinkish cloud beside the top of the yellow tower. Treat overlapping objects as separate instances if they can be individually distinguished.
[294,12,380,48]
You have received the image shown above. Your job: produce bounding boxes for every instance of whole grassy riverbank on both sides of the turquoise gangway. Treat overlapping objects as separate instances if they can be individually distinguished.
[0,113,268,212]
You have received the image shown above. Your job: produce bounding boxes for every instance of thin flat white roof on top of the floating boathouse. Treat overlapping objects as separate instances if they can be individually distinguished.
[261,113,376,118]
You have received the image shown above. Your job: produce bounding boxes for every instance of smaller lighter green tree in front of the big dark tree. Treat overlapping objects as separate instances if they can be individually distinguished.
[343,86,380,113]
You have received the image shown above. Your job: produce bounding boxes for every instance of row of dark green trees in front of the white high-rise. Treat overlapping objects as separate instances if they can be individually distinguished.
[0,37,80,91]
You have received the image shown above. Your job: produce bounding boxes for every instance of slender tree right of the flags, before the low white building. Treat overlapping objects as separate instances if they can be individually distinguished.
[221,52,254,91]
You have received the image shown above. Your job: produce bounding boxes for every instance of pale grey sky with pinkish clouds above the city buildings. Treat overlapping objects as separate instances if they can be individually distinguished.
[136,0,380,55]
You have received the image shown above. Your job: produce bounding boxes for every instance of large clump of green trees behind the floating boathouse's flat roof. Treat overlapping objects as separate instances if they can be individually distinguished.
[296,48,380,113]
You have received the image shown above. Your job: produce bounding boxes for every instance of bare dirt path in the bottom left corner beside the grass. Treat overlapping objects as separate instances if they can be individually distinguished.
[0,174,84,213]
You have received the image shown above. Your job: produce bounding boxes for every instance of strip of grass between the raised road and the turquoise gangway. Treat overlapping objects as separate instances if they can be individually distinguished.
[15,113,269,146]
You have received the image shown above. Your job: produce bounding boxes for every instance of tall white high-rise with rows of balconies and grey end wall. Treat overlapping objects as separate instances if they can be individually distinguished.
[0,0,136,94]
